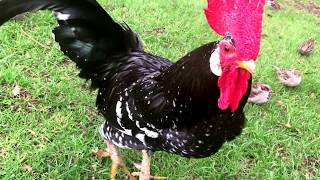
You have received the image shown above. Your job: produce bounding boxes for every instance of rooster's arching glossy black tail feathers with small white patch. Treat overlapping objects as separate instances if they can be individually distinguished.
[0,0,143,88]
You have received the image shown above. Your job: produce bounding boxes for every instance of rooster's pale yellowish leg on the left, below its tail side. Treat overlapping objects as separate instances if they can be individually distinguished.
[106,141,134,180]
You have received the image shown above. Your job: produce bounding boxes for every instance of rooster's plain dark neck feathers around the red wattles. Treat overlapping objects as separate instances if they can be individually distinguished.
[159,42,251,114]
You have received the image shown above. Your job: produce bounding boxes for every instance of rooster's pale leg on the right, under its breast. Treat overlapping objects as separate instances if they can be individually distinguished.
[132,150,166,180]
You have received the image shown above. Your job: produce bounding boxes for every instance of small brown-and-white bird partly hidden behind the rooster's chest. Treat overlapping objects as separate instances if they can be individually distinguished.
[248,83,272,104]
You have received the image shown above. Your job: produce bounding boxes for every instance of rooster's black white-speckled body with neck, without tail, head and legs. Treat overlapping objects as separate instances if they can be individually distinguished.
[97,42,251,157]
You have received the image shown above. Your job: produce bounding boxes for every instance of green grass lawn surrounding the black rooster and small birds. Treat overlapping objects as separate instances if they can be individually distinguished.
[0,0,320,180]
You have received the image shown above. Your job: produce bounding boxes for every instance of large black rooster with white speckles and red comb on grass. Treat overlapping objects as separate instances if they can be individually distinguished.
[0,0,265,179]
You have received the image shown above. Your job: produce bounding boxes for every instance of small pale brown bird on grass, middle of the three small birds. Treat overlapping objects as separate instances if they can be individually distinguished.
[273,65,302,87]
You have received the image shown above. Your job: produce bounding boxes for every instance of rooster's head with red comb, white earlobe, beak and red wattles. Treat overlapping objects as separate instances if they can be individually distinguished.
[205,0,265,112]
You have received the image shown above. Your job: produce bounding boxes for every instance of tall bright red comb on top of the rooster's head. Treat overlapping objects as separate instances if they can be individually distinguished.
[205,0,265,60]
